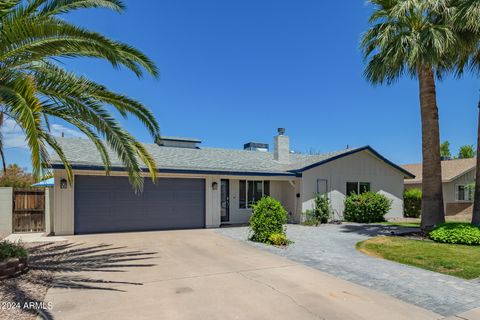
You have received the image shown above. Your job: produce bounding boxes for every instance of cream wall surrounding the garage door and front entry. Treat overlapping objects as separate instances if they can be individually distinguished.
[51,169,294,235]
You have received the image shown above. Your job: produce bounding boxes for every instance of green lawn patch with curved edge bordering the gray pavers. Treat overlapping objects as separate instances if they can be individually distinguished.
[356,236,480,279]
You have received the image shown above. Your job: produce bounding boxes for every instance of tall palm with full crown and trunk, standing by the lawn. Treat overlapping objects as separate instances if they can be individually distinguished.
[361,0,470,230]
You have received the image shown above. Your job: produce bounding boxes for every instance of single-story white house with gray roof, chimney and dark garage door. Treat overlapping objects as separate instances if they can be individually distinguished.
[47,129,413,235]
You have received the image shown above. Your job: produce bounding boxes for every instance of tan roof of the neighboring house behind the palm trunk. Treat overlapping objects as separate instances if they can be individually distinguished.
[402,158,477,184]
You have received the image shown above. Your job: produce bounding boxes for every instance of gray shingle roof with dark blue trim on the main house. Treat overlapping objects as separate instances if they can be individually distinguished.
[51,138,409,176]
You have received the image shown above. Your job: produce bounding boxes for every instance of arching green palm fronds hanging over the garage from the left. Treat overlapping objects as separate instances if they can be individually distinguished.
[0,0,159,190]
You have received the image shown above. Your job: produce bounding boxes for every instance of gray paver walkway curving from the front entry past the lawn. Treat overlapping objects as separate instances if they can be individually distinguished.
[217,224,480,316]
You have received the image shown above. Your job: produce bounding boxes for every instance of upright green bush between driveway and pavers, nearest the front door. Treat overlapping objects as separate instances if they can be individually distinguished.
[250,197,287,243]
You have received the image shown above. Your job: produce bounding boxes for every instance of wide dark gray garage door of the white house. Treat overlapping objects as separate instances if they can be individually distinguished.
[75,176,205,234]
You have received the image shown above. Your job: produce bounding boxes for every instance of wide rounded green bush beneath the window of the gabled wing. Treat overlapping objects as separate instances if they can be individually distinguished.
[343,192,392,223]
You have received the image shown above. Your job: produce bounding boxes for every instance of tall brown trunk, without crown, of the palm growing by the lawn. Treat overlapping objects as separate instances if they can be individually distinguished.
[418,68,445,232]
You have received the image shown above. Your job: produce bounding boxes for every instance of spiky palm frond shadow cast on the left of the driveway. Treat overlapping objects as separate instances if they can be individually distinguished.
[0,243,157,319]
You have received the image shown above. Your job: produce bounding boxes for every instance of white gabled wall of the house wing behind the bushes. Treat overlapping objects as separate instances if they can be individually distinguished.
[301,151,404,219]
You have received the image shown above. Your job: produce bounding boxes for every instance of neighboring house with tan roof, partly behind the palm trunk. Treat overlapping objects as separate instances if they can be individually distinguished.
[402,158,477,216]
